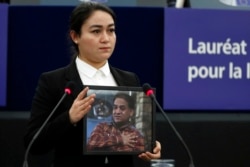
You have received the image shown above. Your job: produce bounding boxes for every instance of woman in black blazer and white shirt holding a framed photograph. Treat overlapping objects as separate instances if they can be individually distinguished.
[24,2,161,167]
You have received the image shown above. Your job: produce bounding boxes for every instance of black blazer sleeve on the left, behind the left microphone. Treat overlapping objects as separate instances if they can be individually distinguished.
[24,71,74,154]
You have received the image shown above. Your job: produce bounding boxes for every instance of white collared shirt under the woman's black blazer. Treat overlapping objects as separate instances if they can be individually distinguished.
[76,57,117,86]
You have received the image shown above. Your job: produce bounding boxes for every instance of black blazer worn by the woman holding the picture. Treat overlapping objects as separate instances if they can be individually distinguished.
[24,61,148,167]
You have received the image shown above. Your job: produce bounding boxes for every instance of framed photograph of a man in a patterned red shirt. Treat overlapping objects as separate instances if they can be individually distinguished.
[83,86,156,155]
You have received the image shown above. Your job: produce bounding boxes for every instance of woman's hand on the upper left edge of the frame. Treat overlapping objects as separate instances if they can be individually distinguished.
[69,87,96,124]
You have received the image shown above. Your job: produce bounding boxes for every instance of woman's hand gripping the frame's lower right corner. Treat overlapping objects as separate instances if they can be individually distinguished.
[138,141,161,161]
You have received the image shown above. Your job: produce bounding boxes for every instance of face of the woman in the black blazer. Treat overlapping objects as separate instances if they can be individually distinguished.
[74,10,116,68]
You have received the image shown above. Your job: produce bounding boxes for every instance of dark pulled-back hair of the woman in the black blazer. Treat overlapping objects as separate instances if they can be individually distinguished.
[69,1,116,57]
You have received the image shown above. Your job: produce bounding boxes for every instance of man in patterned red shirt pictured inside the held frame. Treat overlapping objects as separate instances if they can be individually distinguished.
[87,93,144,151]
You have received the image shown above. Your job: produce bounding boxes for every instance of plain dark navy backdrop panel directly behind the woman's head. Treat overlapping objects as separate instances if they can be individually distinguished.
[4,6,164,111]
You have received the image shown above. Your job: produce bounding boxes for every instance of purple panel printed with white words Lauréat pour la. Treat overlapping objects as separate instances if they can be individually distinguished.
[163,8,250,112]
